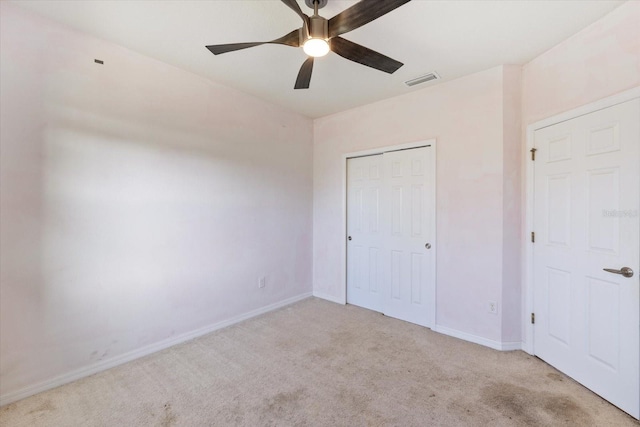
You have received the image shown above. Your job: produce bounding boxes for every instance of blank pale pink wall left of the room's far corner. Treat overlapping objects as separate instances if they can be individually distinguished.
[0,2,313,398]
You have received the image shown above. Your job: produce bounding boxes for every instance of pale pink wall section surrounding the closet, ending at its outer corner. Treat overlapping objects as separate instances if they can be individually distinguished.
[314,67,519,348]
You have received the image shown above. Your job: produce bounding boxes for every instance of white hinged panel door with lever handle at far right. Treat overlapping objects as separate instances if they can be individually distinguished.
[533,100,640,418]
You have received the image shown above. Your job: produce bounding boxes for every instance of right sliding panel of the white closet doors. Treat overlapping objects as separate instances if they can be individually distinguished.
[384,147,435,327]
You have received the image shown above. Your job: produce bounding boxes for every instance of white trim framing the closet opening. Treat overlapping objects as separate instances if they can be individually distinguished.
[334,138,438,329]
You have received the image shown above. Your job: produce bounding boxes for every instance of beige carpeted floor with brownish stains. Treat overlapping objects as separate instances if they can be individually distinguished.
[0,298,640,427]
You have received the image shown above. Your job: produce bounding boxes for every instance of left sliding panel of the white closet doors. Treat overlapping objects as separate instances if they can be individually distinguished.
[347,155,383,312]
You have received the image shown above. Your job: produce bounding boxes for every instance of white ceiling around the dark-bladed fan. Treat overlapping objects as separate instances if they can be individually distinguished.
[8,0,624,118]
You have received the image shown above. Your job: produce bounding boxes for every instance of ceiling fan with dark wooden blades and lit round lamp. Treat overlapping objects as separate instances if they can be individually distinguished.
[207,0,411,89]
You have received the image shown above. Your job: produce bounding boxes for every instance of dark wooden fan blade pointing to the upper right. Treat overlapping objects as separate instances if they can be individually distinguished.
[329,0,411,37]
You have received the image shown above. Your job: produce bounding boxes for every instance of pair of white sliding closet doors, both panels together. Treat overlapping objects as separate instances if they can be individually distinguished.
[347,146,435,327]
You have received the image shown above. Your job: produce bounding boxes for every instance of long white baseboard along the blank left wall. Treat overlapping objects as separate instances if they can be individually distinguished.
[0,292,311,407]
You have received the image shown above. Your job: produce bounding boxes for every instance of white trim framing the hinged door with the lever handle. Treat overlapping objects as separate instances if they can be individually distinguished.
[521,86,640,355]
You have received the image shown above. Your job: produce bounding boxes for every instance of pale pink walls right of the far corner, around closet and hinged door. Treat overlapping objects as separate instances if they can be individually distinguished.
[314,1,640,350]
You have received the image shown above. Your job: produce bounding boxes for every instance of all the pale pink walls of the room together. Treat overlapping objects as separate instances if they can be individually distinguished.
[0,1,640,400]
